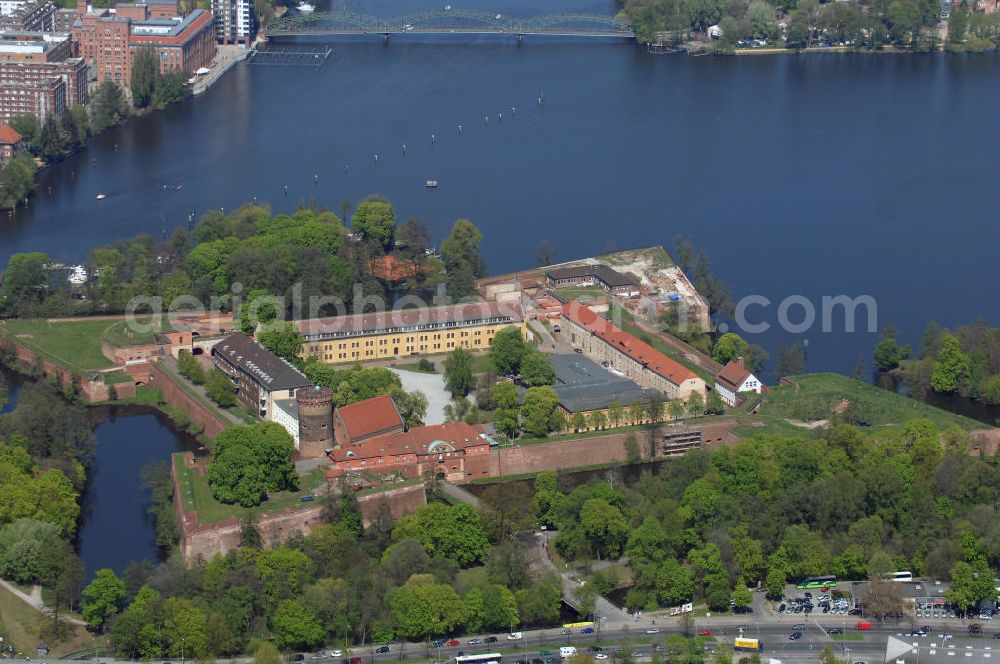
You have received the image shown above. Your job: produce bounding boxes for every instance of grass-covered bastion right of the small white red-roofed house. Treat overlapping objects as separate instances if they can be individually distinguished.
[756,373,987,432]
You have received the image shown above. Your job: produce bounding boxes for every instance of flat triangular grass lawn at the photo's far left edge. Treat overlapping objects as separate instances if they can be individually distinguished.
[0,318,113,373]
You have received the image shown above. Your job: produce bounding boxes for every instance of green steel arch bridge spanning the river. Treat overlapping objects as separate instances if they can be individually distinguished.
[264,9,635,38]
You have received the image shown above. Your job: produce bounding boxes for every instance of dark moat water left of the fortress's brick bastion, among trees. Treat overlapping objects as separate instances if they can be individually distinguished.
[79,408,193,578]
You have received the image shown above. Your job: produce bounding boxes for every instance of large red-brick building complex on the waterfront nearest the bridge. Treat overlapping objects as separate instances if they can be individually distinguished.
[73,0,215,86]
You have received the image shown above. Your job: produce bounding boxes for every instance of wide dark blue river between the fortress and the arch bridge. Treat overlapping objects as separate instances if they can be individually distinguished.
[0,28,1000,373]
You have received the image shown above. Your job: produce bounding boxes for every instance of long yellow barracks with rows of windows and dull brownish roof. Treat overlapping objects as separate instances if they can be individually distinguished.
[295,302,525,364]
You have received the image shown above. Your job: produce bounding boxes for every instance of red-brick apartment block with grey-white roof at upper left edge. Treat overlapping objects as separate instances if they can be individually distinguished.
[0,32,87,122]
